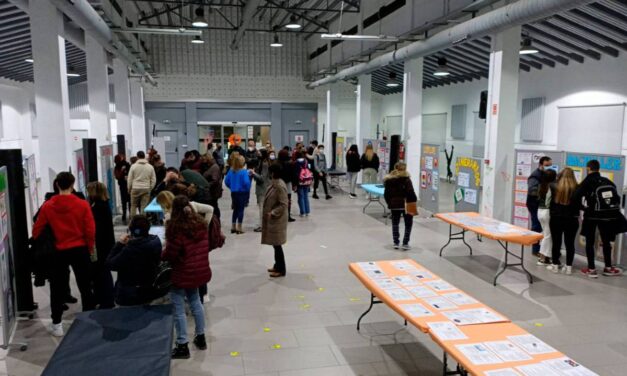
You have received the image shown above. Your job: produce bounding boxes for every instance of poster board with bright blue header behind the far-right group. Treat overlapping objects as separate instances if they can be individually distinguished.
[565,152,625,264]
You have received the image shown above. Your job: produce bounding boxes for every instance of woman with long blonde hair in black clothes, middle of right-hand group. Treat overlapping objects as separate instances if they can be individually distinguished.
[547,167,579,275]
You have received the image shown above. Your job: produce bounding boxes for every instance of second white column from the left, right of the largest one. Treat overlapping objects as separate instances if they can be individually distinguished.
[85,33,111,146]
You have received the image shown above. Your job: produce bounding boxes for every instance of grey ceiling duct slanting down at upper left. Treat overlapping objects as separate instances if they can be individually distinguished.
[45,0,157,86]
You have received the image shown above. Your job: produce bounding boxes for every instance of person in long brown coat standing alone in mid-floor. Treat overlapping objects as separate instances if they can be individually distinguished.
[261,163,288,278]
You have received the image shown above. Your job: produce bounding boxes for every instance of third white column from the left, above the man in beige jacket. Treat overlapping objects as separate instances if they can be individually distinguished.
[113,59,132,154]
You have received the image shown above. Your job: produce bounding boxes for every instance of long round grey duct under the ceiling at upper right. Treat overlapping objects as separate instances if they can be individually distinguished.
[307,0,594,89]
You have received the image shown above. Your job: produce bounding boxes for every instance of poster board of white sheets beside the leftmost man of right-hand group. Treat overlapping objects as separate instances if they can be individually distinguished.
[512,150,564,228]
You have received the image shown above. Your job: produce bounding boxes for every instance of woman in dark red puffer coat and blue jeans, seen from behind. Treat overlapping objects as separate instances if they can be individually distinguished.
[161,196,211,359]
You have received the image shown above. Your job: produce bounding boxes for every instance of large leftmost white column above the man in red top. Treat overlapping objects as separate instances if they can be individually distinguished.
[30,1,72,189]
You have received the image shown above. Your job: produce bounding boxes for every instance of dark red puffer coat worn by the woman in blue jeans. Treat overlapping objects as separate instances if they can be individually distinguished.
[161,230,211,289]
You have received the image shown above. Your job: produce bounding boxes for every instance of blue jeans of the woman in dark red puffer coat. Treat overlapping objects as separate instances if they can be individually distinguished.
[170,287,205,345]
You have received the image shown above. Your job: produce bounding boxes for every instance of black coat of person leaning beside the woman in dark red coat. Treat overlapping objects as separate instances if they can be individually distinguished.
[106,235,162,305]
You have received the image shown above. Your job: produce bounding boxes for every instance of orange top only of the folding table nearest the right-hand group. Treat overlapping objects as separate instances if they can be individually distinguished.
[435,212,543,245]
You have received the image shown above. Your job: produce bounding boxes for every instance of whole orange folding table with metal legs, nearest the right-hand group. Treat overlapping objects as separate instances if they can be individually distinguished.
[435,212,542,286]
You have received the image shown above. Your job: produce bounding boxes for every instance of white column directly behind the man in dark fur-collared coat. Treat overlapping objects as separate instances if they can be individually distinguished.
[401,58,423,195]
